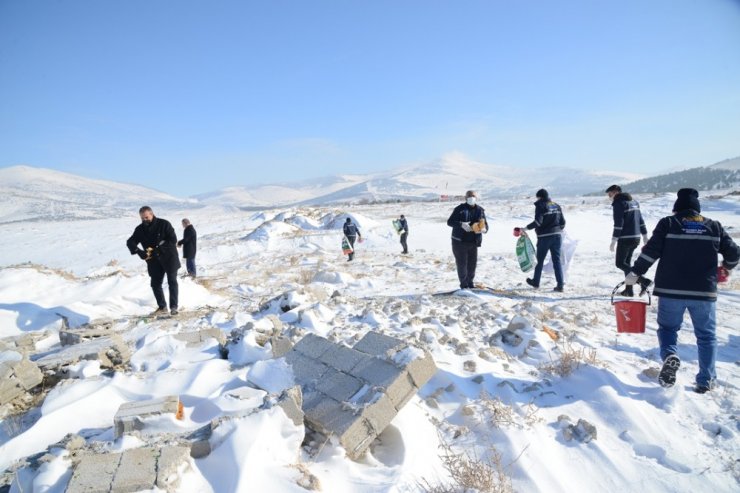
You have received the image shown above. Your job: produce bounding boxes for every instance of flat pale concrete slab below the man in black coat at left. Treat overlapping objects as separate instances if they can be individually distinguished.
[35,334,131,370]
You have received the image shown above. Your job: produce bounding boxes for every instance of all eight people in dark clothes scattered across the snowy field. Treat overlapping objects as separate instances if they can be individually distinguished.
[126,185,740,393]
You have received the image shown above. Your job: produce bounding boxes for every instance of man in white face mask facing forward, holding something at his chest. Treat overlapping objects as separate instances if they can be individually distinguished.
[447,190,488,289]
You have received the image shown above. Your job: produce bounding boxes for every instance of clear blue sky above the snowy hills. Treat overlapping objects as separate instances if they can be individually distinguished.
[0,0,740,196]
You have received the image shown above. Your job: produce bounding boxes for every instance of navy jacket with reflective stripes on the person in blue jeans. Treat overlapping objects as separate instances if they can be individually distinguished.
[632,210,740,301]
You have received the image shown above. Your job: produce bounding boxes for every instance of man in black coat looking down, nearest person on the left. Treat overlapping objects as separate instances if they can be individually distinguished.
[126,206,180,315]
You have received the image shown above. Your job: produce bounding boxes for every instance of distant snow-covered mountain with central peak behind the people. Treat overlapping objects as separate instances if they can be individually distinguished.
[196,153,640,207]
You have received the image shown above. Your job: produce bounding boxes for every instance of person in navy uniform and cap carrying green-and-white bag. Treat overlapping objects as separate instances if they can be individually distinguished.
[522,188,565,292]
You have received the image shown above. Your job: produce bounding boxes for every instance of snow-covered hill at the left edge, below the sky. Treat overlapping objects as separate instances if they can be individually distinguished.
[0,166,193,224]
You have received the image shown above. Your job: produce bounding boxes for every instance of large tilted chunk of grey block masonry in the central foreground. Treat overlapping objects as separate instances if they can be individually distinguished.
[285,332,437,459]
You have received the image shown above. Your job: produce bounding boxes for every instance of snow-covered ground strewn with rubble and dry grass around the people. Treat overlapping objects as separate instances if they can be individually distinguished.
[0,195,740,492]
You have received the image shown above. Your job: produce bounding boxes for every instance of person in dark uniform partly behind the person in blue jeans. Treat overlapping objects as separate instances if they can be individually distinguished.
[606,185,652,296]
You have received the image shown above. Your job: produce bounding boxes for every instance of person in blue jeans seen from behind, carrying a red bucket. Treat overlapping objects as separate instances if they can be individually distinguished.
[625,188,740,394]
